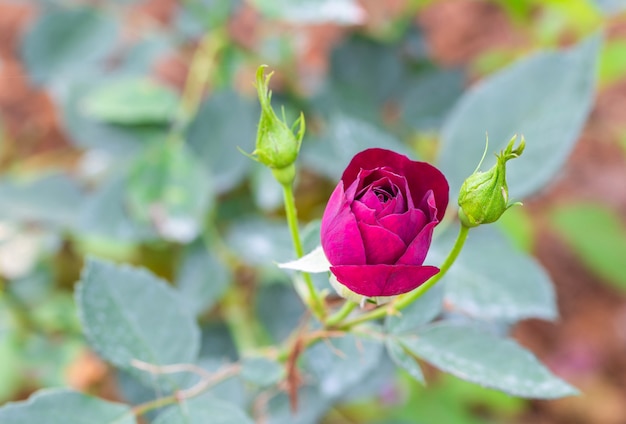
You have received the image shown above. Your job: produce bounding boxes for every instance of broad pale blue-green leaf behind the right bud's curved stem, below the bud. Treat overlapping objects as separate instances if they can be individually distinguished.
[426,226,558,322]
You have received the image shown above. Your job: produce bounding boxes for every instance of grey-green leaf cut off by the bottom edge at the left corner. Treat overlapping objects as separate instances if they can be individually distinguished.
[0,389,136,424]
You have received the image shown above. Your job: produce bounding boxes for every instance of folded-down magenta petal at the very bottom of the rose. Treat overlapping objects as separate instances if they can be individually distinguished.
[330,265,439,297]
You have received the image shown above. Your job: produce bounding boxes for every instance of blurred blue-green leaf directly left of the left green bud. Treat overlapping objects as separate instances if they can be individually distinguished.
[187,90,259,194]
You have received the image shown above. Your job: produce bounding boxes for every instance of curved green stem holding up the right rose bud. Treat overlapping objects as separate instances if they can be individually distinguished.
[337,224,469,330]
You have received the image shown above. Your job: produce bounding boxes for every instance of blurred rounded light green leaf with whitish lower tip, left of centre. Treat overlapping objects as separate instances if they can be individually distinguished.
[127,143,212,243]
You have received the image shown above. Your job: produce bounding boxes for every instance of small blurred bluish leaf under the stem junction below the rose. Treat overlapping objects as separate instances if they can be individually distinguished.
[304,334,383,399]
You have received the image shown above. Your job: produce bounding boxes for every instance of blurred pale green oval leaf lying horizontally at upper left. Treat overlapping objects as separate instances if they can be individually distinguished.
[82,78,179,125]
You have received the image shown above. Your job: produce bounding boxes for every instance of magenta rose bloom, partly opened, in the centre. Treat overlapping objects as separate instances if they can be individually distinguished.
[321,149,449,297]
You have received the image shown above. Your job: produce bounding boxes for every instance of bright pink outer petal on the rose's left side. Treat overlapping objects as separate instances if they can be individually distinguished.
[320,182,365,265]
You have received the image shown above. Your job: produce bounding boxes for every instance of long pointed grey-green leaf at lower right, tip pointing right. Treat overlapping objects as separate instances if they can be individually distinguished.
[399,322,578,399]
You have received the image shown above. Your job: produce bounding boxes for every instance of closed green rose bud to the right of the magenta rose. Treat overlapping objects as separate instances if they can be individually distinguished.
[459,135,526,227]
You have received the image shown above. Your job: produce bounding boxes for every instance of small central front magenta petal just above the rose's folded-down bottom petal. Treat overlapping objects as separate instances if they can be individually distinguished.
[356,222,406,265]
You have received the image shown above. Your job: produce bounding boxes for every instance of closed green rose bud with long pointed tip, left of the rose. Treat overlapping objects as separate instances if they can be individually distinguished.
[251,65,305,184]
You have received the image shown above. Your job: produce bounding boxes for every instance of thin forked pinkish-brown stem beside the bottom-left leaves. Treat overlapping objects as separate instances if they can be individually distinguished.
[131,359,241,416]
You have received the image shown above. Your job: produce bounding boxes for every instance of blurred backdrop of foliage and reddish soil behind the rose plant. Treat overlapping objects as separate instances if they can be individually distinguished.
[0,0,626,424]
